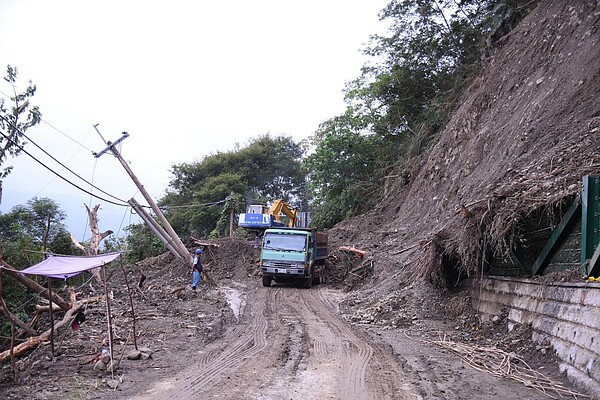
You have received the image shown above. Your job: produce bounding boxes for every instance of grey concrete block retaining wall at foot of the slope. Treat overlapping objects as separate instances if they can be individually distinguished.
[465,277,600,398]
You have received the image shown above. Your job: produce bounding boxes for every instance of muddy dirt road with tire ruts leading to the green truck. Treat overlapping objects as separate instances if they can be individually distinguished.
[136,286,418,399]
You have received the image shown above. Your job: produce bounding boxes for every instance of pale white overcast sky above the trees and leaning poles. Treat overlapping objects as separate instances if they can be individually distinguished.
[0,0,388,240]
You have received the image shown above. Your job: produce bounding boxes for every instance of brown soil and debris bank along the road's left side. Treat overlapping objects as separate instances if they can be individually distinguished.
[0,239,258,399]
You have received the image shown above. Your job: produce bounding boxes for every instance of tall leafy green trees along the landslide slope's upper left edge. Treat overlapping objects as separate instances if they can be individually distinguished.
[304,0,535,227]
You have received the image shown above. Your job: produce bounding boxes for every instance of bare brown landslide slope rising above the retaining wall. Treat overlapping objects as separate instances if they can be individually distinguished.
[330,0,600,283]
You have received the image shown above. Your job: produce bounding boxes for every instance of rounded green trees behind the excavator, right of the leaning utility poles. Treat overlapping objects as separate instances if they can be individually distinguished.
[159,134,306,237]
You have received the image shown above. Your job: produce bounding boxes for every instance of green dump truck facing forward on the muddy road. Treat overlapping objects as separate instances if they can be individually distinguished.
[259,227,328,288]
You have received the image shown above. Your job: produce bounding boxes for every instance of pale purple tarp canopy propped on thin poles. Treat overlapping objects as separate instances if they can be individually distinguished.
[14,251,121,279]
